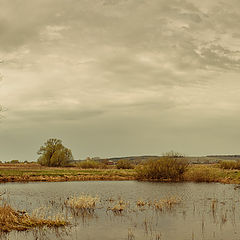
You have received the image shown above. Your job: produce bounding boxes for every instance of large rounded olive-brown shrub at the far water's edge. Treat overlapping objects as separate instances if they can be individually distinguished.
[137,152,188,180]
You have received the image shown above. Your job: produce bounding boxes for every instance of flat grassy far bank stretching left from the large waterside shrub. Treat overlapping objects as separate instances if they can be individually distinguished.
[0,164,135,182]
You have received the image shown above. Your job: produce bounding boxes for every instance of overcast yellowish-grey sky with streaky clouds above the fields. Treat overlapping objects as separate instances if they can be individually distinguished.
[0,0,240,161]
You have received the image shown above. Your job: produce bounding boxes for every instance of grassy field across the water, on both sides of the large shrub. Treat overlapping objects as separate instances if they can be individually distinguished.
[0,163,240,184]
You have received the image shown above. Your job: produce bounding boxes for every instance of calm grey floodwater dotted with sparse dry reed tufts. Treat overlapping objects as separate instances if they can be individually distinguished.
[0,181,240,240]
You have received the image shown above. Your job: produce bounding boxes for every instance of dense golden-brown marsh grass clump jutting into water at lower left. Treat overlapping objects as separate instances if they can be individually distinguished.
[0,204,67,232]
